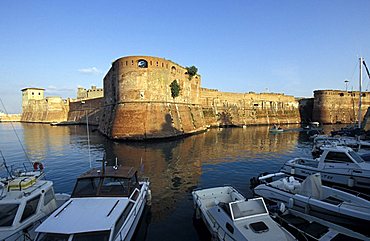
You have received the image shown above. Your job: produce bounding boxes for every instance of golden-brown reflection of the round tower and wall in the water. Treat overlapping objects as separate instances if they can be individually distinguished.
[105,126,299,220]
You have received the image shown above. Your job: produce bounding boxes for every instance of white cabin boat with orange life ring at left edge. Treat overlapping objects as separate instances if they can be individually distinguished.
[0,162,70,241]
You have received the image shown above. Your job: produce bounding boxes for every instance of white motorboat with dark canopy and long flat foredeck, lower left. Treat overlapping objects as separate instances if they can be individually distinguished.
[36,164,150,241]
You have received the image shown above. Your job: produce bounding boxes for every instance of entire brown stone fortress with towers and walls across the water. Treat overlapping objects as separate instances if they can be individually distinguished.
[15,56,370,140]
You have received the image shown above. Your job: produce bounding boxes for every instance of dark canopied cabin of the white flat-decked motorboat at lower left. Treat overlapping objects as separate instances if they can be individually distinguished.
[71,166,140,198]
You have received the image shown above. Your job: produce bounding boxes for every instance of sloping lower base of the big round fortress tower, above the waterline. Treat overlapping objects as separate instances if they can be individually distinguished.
[99,102,205,140]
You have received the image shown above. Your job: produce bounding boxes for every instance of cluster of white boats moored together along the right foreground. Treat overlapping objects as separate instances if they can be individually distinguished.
[192,136,370,241]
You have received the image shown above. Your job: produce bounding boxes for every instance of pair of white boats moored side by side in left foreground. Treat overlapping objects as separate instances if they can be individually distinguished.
[0,162,151,241]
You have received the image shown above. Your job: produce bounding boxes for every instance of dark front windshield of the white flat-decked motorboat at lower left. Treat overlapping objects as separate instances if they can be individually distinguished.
[72,177,132,197]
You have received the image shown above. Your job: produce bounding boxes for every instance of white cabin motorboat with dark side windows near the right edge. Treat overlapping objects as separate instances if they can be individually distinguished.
[280,146,370,191]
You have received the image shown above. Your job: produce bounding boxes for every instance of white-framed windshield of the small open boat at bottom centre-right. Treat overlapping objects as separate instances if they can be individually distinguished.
[230,198,268,220]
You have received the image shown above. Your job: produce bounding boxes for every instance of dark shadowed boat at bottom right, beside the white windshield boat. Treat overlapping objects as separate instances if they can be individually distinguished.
[270,204,370,241]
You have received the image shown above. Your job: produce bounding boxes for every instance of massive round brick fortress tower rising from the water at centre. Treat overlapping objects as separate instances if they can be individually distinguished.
[99,56,206,139]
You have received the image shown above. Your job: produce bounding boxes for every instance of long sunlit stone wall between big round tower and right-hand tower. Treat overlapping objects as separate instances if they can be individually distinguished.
[201,88,301,126]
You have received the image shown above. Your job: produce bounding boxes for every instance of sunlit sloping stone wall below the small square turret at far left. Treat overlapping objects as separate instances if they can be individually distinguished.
[21,97,69,123]
